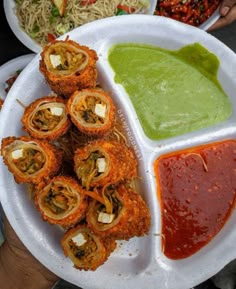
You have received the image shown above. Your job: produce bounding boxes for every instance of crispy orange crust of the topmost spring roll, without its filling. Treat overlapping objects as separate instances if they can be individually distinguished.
[39,40,98,97]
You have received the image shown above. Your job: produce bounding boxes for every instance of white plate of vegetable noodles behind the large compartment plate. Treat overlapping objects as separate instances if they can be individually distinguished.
[4,0,156,52]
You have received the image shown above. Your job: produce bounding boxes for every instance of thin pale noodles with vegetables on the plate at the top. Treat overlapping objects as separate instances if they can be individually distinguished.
[16,0,149,46]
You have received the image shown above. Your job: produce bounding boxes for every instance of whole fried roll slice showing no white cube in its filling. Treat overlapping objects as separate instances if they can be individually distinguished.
[35,176,88,228]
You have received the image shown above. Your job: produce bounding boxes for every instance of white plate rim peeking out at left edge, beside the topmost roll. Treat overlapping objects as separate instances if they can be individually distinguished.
[0,53,35,99]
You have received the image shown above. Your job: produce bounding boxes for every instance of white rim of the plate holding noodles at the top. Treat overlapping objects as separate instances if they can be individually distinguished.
[3,0,157,53]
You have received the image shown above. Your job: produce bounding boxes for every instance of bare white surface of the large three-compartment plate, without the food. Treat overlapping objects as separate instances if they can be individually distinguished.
[0,15,236,289]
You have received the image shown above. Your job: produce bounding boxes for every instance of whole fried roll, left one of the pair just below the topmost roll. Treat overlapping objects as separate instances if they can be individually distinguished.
[21,96,71,141]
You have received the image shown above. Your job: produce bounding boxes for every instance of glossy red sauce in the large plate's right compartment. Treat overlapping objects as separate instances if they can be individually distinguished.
[154,140,236,259]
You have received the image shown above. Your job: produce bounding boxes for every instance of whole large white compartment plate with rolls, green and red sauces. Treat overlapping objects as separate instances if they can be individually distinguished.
[0,15,236,289]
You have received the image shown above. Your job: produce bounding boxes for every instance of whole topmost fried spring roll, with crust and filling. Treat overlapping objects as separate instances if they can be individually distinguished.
[39,39,98,97]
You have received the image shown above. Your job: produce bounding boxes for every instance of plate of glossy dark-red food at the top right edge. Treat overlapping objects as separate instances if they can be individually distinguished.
[154,0,221,30]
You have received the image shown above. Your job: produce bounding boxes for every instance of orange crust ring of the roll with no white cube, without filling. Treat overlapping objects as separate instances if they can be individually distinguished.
[34,176,88,228]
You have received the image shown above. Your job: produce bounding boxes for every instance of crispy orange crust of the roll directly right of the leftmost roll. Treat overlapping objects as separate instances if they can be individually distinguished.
[74,140,137,187]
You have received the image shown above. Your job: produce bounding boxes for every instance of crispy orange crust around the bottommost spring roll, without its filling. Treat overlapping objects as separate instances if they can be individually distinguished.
[61,225,116,271]
